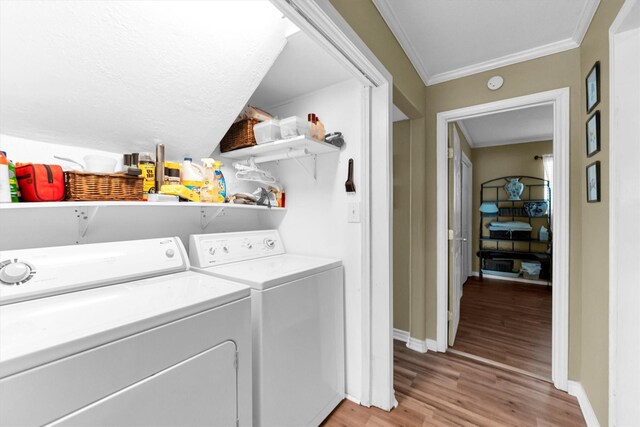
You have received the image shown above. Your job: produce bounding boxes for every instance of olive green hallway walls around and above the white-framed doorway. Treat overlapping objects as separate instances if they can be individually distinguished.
[331,0,623,425]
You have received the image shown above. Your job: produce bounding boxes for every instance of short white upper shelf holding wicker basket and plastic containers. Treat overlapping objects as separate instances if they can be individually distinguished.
[221,135,340,161]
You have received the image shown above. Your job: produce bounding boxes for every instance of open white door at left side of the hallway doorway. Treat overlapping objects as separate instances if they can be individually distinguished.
[449,126,464,345]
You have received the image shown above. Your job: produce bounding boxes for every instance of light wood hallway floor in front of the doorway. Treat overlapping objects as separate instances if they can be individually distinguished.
[323,341,586,427]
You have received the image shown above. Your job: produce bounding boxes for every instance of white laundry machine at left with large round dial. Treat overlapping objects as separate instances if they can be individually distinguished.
[0,237,252,426]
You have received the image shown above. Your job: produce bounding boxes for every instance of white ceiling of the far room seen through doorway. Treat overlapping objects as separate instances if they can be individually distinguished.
[458,105,553,148]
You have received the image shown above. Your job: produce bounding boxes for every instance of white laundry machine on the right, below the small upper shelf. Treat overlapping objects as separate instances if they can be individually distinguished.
[189,230,345,427]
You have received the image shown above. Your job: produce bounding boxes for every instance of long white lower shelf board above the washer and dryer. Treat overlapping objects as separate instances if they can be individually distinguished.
[0,201,287,211]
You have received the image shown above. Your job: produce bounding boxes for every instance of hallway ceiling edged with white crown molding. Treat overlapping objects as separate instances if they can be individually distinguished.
[373,0,599,84]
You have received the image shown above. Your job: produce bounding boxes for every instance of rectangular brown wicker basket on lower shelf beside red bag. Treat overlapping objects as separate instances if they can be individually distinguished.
[64,171,144,201]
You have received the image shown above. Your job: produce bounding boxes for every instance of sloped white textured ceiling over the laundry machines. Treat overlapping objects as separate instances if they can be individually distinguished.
[0,1,290,158]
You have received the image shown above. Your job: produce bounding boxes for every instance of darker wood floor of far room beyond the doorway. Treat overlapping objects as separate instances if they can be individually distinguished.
[452,277,551,379]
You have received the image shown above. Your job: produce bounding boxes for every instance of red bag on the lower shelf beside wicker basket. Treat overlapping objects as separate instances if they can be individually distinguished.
[16,163,64,202]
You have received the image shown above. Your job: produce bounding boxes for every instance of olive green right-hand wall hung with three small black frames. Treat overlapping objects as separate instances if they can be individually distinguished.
[572,0,624,425]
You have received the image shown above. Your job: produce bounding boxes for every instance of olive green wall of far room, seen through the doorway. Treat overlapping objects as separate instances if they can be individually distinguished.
[471,141,553,271]
